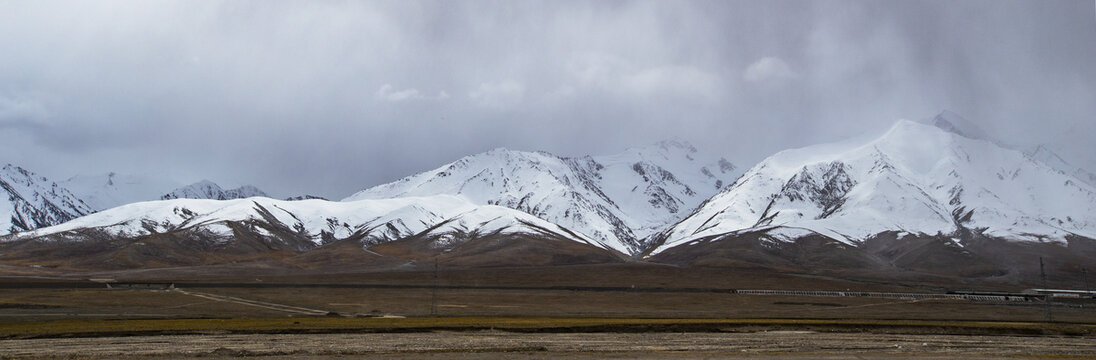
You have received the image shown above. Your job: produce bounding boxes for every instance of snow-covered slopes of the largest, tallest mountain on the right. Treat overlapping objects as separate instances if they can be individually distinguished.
[651,121,1096,255]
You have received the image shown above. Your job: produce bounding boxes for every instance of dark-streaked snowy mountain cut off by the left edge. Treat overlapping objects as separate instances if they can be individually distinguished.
[0,164,92,235]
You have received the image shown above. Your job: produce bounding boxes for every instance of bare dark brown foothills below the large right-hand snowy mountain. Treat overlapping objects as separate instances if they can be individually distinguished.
[648,232,1096,289]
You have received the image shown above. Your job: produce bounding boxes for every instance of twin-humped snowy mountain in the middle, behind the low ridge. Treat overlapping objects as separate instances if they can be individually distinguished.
[343,142,740,255]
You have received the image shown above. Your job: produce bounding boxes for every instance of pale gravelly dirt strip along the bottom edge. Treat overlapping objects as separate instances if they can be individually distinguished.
[0,331,1096,359]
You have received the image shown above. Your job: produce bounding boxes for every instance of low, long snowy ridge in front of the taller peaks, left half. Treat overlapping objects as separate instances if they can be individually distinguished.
[12,195,596,250]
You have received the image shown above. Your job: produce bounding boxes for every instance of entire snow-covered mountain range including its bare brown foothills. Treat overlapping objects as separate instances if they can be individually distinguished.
[0,112,1096,281]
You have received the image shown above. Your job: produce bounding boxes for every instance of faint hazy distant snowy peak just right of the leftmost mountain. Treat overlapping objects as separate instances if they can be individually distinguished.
[60,172,182,211]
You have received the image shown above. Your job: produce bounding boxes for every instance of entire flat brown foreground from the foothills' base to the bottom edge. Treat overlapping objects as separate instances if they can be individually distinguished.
[0,265,1096,359]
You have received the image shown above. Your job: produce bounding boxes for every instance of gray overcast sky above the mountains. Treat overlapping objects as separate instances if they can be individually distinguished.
[0,0,1096,199]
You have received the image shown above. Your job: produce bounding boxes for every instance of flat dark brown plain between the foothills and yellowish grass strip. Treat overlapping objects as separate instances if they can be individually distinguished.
[0,263,1096,323]
